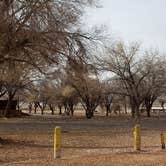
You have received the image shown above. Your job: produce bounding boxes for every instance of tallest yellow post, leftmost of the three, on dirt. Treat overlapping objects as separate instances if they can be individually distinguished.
[54,127,61,159]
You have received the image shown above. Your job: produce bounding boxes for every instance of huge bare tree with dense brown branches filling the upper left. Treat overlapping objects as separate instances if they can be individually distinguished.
[0,0,101,117]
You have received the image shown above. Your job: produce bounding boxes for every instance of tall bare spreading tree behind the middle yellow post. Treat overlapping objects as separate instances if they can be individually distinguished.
[99,42,156,117]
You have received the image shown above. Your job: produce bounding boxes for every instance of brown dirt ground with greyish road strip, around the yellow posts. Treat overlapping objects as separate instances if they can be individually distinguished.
[0,115,166,166]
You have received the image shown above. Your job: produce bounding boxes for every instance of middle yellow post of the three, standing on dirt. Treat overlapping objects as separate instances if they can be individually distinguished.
[134,125,141,150]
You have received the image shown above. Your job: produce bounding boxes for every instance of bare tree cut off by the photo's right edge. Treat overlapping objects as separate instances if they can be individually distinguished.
[142,51,166,117]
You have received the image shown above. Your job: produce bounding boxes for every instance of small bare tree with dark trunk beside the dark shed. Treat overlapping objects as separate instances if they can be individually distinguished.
[1,62,36,116]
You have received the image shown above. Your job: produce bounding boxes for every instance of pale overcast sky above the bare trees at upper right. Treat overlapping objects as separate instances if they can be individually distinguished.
[85,0,166,52]
